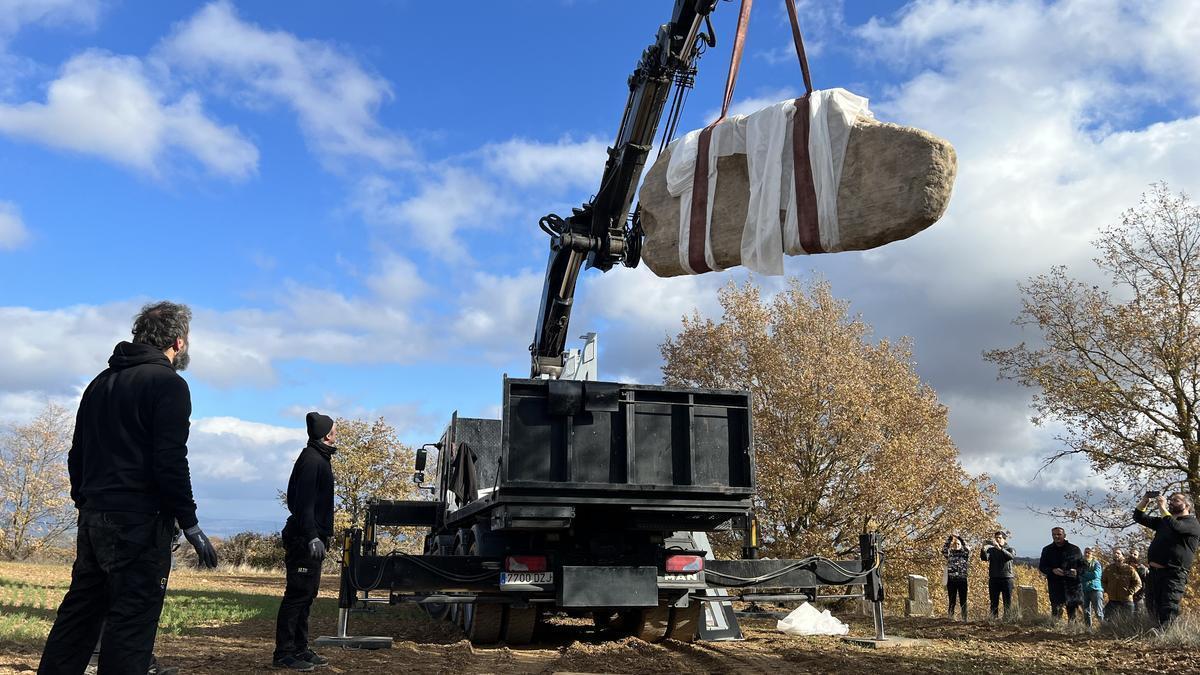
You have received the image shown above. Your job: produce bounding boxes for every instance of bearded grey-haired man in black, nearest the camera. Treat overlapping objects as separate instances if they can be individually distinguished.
[37,301,217,675]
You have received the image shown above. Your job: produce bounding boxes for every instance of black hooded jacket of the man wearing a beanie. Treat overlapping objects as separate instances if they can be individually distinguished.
[283,440,337,542]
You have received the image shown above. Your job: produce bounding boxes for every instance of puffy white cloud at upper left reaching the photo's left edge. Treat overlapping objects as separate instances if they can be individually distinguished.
[0,50,258,179]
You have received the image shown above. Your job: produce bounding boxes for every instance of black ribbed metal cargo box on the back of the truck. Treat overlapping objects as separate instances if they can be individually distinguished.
[499,380,754,494]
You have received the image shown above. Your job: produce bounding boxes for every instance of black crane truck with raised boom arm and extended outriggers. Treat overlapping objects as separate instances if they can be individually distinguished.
[323,0,883,646]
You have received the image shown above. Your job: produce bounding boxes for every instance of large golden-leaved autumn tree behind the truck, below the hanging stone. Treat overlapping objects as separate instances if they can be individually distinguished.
[661,280,996,579]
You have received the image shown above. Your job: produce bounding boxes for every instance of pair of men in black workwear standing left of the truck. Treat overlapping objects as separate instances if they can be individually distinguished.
[37,301,337,675]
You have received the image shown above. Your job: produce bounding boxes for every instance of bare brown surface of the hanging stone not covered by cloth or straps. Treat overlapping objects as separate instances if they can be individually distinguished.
[638,117,958,276]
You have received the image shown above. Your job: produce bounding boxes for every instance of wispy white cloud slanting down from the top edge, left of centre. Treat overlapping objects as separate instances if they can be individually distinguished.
[160,1,412,166]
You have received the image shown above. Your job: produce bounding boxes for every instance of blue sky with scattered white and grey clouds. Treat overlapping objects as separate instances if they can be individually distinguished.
[0,0,1200,555]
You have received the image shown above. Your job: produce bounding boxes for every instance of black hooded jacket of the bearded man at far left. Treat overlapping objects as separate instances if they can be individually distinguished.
[67,342,196,530]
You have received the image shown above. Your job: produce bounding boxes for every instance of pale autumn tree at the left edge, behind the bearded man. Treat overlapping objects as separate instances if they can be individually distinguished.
[0,404,76,560]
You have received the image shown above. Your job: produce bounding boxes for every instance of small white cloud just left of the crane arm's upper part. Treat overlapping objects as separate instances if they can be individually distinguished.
[484,138,608,191]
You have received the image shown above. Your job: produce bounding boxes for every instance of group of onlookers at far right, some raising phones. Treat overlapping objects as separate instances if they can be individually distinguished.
[942,492,1200,627]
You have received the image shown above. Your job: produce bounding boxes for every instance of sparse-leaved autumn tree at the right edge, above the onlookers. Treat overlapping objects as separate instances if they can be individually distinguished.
[984,184,1200,527]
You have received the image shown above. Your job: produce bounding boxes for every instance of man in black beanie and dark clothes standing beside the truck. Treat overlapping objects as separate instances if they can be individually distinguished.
[271,412,337,671]
